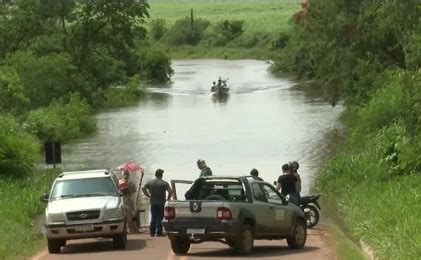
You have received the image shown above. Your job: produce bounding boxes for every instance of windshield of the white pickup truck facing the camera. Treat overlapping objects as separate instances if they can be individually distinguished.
[51,178,117,199]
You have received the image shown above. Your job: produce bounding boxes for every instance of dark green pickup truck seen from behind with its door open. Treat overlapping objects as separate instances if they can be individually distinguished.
[163,176,307,254]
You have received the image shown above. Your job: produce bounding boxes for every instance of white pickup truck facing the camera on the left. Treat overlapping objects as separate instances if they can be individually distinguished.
[41,170,127,253]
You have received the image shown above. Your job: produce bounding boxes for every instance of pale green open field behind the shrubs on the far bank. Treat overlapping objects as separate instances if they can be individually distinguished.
[150,0,300,34]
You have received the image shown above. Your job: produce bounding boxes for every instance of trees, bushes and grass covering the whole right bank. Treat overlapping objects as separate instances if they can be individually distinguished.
[272,0,421,259]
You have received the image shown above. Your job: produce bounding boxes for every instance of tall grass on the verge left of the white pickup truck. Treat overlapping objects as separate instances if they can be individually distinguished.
[0,170,58,259]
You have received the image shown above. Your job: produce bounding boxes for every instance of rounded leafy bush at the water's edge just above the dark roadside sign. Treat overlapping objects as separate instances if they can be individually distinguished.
[26,95,96,142]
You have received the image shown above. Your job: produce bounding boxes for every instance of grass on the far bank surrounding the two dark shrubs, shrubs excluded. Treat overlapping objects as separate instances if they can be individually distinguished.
[148,0,301,59]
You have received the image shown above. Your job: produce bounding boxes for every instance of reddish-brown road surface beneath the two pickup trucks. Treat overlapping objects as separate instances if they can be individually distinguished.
[31,225,335,260]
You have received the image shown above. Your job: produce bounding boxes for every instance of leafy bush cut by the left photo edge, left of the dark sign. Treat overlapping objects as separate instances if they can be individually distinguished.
[0,114,39,175]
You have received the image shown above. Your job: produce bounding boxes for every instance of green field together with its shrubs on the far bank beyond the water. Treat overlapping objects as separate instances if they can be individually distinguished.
[148,0,300,58]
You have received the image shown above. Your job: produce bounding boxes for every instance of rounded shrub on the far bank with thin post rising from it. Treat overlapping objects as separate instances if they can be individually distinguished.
[164,17,210,46]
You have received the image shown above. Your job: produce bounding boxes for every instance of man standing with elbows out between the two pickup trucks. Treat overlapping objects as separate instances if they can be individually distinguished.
[142,169,173,237]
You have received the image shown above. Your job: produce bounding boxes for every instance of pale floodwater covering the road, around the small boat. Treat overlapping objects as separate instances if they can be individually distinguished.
[62,60,342,194]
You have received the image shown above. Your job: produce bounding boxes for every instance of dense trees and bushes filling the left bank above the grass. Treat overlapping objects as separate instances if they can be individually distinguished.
[0,0,173,177]
